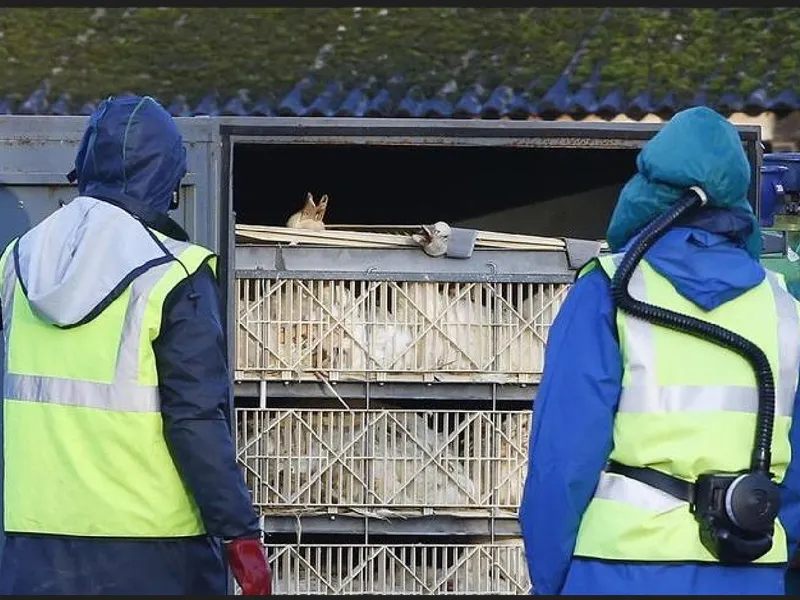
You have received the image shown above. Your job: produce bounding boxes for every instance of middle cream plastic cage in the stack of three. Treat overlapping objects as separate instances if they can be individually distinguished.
[236,409,531,515]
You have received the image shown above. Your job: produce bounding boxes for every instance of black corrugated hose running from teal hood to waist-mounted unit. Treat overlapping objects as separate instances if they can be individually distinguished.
[611,188,775,477]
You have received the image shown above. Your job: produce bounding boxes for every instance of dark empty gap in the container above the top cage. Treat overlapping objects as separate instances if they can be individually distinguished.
[232,142,638,239]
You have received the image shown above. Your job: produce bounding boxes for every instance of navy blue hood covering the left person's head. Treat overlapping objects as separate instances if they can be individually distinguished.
[75,96,186,222]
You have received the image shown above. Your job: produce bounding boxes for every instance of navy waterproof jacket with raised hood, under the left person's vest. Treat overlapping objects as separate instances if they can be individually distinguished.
[0,97,259,595]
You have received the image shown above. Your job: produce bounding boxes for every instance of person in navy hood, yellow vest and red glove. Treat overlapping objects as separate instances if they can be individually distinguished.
[0,97,271,595]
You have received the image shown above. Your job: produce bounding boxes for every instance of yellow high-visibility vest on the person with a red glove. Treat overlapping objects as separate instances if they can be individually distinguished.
[0,234,215,538]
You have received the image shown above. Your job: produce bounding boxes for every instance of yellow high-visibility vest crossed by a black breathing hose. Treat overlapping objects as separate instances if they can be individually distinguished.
[575,255,800,563]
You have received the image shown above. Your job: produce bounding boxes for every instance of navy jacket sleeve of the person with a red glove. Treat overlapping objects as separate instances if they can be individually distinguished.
[153,265,260,539]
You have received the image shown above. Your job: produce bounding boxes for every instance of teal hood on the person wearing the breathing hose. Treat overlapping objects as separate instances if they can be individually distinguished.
[607,106,761,259]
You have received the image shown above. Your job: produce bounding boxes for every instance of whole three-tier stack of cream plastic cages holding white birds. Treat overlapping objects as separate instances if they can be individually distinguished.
[234,232,592,594]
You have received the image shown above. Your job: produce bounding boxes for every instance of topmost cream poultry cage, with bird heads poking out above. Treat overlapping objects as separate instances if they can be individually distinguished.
[235,227,599,384]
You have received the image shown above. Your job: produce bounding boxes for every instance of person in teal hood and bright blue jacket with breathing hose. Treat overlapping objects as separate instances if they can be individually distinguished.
[519,107,800,595]
